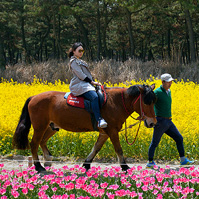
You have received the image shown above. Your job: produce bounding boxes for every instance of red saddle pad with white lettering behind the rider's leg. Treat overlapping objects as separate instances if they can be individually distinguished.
[64,93,85,108]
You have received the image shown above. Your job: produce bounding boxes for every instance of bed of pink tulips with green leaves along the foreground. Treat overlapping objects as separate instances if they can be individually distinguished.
[0,164,199,199]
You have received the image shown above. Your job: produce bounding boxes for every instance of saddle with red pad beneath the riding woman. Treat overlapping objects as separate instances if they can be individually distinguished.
[64,85,107,113]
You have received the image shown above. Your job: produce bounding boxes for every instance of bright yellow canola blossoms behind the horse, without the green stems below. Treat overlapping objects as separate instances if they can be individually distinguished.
[0,76,199,157]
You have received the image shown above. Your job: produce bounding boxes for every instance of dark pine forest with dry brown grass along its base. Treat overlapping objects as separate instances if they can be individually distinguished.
[0,0,199,83]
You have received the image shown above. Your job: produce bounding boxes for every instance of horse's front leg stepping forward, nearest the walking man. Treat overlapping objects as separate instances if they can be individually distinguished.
[109,131,130,171]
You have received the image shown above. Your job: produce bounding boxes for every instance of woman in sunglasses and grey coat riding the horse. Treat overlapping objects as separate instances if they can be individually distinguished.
[69,42,107,128]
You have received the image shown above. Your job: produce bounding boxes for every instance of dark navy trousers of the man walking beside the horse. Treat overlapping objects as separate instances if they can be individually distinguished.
[148,117,184,161]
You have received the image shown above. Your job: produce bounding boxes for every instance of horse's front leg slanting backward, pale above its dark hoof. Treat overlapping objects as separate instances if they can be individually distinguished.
[83,133,109,171]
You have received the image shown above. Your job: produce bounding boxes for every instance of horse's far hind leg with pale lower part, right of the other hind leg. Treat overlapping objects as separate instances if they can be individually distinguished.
[40,127,57,167]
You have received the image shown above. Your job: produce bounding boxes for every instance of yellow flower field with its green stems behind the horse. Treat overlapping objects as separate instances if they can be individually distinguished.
[0,77,199,160]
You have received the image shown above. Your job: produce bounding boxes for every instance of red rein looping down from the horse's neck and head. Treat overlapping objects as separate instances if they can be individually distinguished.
[121,89,144,145]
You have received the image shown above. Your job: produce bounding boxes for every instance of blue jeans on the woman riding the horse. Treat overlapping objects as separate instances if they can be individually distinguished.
[82,91,101,121]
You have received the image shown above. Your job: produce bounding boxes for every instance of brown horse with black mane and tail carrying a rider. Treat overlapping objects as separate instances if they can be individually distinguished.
[13,85,157,172]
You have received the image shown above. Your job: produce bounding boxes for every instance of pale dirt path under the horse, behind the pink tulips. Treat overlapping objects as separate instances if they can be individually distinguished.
[0,155,199,170]
